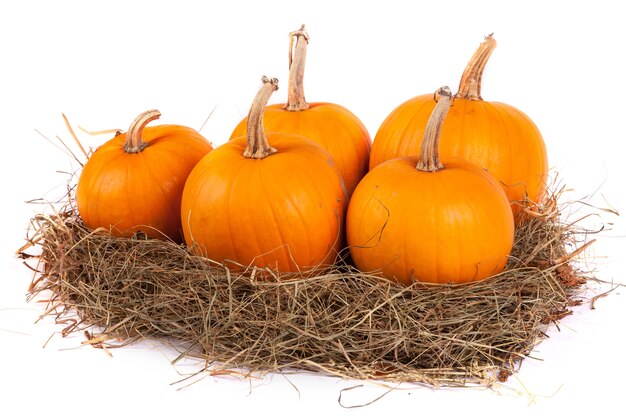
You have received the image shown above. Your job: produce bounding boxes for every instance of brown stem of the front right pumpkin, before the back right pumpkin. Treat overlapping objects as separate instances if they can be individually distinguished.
[416,86,452,172]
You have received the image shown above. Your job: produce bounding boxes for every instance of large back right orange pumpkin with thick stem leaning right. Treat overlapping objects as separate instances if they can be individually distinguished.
[370,35,548,219]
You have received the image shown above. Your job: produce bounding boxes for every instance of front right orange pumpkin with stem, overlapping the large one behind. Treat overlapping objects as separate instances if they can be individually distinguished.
[346,87,514,285]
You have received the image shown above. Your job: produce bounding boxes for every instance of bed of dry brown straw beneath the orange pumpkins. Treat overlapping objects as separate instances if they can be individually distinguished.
[18,181,591,386]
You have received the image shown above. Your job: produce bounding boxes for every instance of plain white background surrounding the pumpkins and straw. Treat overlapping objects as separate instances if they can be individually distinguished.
[0,0,626,416]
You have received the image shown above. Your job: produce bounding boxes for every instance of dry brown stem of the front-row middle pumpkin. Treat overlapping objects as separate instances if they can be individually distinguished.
[243,76,278,159]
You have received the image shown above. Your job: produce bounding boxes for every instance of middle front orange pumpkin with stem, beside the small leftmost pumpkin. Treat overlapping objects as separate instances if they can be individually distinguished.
[182,77,347,272]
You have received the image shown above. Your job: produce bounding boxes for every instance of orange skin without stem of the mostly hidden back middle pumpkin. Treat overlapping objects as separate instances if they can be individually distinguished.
[231,103,372,195]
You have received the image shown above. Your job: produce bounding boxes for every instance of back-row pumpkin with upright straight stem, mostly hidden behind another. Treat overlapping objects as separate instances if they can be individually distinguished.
[231,25,372,194]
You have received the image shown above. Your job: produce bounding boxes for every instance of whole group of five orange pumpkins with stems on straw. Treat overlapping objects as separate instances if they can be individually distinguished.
[76,31,547,285]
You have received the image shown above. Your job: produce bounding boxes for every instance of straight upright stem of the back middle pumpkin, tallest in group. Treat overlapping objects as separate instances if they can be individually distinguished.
[283,25,309,111]
